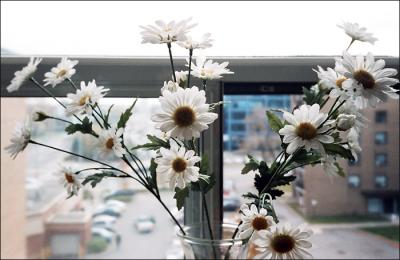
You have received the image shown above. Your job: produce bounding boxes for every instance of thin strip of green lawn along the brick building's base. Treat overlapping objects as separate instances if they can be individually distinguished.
[289,203,388,224]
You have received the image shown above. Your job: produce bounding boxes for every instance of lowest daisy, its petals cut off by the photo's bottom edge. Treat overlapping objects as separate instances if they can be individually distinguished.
[254,225,313,259]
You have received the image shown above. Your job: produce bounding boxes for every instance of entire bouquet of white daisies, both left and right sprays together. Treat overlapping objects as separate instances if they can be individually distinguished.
[6,19,398,259]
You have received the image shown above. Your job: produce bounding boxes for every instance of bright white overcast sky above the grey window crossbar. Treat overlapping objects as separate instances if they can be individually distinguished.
[1,1,399,56]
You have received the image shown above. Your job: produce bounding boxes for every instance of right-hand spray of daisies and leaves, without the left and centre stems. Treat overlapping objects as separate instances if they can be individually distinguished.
[233,22,399,259]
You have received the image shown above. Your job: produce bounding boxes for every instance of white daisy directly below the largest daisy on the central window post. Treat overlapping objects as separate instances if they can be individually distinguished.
[155,139,201,189]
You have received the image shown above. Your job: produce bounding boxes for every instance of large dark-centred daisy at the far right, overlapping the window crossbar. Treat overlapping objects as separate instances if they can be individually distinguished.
[337,51,399,108]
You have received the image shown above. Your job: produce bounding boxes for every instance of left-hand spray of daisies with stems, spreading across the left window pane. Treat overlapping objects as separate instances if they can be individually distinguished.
[6,19,233,242]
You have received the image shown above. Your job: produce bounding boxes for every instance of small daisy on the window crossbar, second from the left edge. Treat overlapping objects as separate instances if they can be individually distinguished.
[43,57,78,88]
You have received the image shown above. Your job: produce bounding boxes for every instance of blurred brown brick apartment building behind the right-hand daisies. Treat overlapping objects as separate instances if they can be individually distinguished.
[294,100,400,216]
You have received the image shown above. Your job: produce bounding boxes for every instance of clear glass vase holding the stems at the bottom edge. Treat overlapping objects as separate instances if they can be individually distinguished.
[177,223,248,259]
